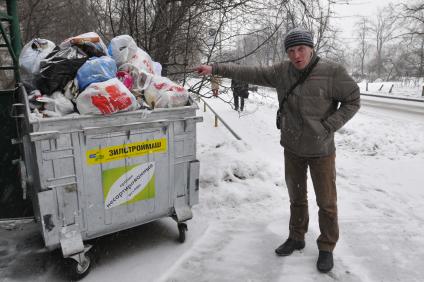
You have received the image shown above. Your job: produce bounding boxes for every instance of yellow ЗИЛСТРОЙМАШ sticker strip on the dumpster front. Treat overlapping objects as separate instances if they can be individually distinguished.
[86,138,166,165]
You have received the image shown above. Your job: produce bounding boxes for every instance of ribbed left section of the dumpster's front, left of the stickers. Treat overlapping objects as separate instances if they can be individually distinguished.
[33,132,84,248]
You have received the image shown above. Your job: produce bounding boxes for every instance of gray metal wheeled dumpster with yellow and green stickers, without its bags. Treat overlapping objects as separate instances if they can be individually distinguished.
[13,87,202,278]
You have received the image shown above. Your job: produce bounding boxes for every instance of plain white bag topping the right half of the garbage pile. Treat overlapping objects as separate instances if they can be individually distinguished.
[108,34,138,67]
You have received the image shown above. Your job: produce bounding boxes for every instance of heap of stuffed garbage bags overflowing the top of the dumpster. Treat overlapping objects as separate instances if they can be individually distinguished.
[19,32,189,117]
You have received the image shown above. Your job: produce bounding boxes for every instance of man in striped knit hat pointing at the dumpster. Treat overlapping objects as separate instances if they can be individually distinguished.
[195,28,360,273]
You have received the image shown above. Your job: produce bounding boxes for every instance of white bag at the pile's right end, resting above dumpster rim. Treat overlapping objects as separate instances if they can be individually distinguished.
[144,76,189,108]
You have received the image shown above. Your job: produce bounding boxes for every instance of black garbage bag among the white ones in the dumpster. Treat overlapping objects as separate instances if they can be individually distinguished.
[37,46,88,95]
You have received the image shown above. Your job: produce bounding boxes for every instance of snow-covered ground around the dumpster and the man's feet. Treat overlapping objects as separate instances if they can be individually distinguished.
[0,81,424,282]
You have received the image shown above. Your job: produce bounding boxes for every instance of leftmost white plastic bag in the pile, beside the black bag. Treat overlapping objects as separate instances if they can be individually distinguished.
[19,38,56,90]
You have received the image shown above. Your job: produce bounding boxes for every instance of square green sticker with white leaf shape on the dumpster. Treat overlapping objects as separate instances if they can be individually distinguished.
[102,162,155,209]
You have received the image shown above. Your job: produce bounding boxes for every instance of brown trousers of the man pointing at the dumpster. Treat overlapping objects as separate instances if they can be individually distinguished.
[284,150,339,252]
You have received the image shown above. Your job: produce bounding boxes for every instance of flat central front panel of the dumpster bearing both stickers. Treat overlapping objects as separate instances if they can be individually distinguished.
[82,124,171,238]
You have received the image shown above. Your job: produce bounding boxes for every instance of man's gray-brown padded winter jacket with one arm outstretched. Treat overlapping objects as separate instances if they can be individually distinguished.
[212,55,360,157]
